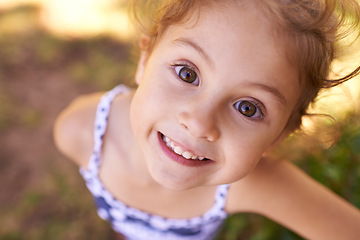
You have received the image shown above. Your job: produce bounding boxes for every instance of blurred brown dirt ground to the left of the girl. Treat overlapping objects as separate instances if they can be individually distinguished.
[0,4,133,239]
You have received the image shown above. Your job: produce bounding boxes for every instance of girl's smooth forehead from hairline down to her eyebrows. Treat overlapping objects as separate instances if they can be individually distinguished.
[148,1,299,109]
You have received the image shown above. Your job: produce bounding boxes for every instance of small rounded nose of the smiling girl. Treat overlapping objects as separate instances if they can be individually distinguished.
[178,103,220,142]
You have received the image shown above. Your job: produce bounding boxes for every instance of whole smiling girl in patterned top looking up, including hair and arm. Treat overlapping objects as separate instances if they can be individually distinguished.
[54,0,360,240]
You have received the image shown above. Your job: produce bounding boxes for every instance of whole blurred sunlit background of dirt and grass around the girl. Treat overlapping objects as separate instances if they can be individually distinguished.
[0,0,360,240]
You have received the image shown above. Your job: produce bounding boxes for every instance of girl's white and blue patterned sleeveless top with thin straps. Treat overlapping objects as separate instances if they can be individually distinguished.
[80,85,229,240]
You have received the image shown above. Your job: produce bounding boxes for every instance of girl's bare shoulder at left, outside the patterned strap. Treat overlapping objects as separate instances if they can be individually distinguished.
[53,93,104,166]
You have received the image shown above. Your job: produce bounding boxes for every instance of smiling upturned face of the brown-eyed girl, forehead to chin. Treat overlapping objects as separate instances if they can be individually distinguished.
[131,1,300,190]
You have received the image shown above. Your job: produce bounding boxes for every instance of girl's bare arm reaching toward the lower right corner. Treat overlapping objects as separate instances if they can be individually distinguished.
[228,159,360,240]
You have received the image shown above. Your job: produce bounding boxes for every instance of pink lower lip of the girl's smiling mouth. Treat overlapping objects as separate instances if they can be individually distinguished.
[158,132,214,167]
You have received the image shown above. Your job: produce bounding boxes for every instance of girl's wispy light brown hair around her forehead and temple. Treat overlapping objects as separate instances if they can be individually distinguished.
[132,0,360,131]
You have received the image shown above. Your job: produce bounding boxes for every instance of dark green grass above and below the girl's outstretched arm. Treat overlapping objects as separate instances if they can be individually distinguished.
[218,113,360,240]
